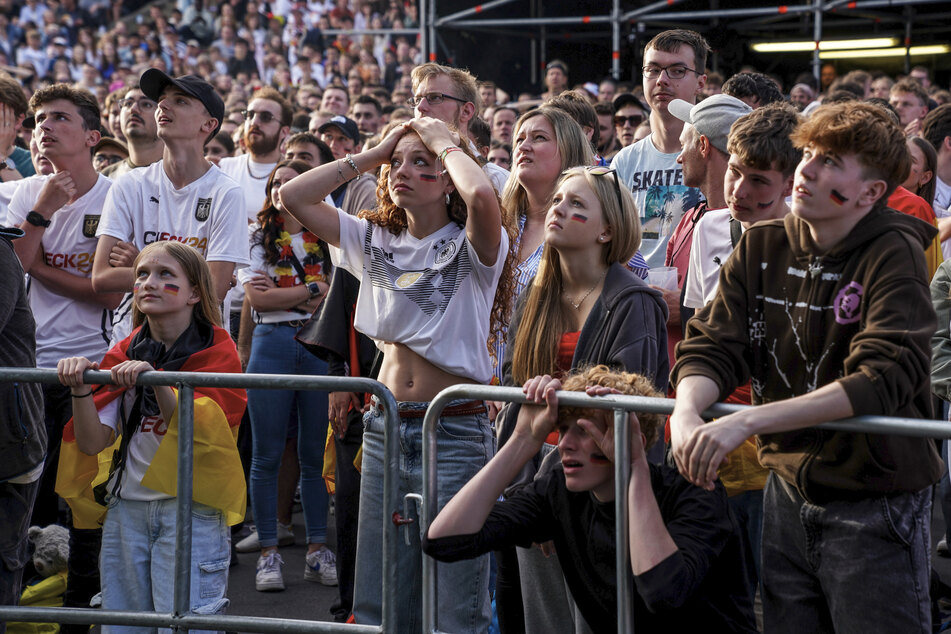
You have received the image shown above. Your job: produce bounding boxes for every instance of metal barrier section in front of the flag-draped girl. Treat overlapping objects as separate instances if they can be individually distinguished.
[0,368,399,634]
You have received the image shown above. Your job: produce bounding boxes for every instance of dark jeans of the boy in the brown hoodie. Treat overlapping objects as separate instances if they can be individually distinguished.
[763,473,931,634]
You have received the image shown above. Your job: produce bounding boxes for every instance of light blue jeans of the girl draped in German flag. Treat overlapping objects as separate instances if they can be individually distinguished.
[99,497,231,634]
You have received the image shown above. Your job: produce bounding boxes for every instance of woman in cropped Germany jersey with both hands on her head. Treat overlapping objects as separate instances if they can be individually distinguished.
[280,117,511,632]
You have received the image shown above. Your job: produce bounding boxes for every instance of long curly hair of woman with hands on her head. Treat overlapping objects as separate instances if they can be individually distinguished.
[358,123,518,363]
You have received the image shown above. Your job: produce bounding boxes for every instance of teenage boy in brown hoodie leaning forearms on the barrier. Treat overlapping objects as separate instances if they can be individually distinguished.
[671,103,942,632]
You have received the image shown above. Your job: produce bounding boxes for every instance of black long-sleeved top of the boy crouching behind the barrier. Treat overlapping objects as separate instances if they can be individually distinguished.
[423,465,756,634]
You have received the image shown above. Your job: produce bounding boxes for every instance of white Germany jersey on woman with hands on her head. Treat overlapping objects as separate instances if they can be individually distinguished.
[330,209,508,383]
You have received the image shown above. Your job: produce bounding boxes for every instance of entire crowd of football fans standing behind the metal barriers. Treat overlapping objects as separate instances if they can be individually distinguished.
[0,0,951,633]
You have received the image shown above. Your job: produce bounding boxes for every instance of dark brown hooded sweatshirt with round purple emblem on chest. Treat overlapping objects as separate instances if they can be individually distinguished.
[671,207,943,504]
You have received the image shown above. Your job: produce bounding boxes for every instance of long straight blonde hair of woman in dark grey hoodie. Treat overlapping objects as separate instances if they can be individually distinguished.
[512,167,641,385]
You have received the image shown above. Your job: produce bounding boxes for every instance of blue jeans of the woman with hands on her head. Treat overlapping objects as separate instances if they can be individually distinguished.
[353,401,495,633]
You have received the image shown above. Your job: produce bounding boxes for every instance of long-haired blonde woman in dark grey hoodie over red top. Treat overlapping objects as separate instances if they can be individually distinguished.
[497,167,669,632]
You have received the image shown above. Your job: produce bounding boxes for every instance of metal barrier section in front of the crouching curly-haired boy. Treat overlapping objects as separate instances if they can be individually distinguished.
[420,385,951,634]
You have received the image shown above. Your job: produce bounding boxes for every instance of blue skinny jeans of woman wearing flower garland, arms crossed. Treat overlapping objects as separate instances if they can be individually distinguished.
[248,324,329,546]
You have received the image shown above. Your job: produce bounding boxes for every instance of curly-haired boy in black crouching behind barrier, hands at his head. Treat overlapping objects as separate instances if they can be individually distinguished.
[423,365,756,632]
